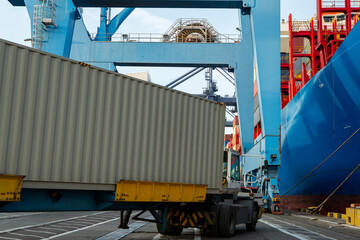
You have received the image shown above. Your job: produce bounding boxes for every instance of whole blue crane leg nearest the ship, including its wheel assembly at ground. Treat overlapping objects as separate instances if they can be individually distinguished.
[246,0,281,211]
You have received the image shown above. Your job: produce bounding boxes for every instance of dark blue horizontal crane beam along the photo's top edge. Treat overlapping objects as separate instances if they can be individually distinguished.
[9,0,254,8]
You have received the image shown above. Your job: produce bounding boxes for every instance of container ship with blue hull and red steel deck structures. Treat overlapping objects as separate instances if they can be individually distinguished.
[279,0,360,214]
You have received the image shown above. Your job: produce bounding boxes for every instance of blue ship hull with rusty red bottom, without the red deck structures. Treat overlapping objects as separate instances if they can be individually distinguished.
[279,24,360,212]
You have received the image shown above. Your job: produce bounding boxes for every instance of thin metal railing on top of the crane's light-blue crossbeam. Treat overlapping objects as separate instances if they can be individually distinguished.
[90,33,240,43]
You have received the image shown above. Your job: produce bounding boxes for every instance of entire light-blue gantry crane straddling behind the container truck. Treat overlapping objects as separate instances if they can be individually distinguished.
[9,0,280,211]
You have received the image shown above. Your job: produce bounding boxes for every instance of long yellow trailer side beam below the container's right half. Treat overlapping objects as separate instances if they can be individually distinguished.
[115,180,207,202]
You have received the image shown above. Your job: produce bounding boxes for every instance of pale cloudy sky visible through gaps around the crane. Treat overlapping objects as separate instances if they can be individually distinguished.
[0,0,316,126]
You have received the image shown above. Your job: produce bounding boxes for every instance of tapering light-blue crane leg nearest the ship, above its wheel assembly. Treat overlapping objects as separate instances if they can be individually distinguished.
[251,0,280,150]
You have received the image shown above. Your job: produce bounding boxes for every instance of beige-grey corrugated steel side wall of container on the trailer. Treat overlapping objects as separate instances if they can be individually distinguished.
[0,39,225,189]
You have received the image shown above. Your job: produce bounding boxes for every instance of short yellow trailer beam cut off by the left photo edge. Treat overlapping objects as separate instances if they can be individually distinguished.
[0,174,25,202]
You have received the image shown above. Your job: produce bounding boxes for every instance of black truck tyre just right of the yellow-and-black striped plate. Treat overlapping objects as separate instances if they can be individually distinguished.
[219,205,236,237]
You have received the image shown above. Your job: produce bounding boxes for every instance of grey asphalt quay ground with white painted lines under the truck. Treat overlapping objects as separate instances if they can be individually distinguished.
[0,211,360,240]
